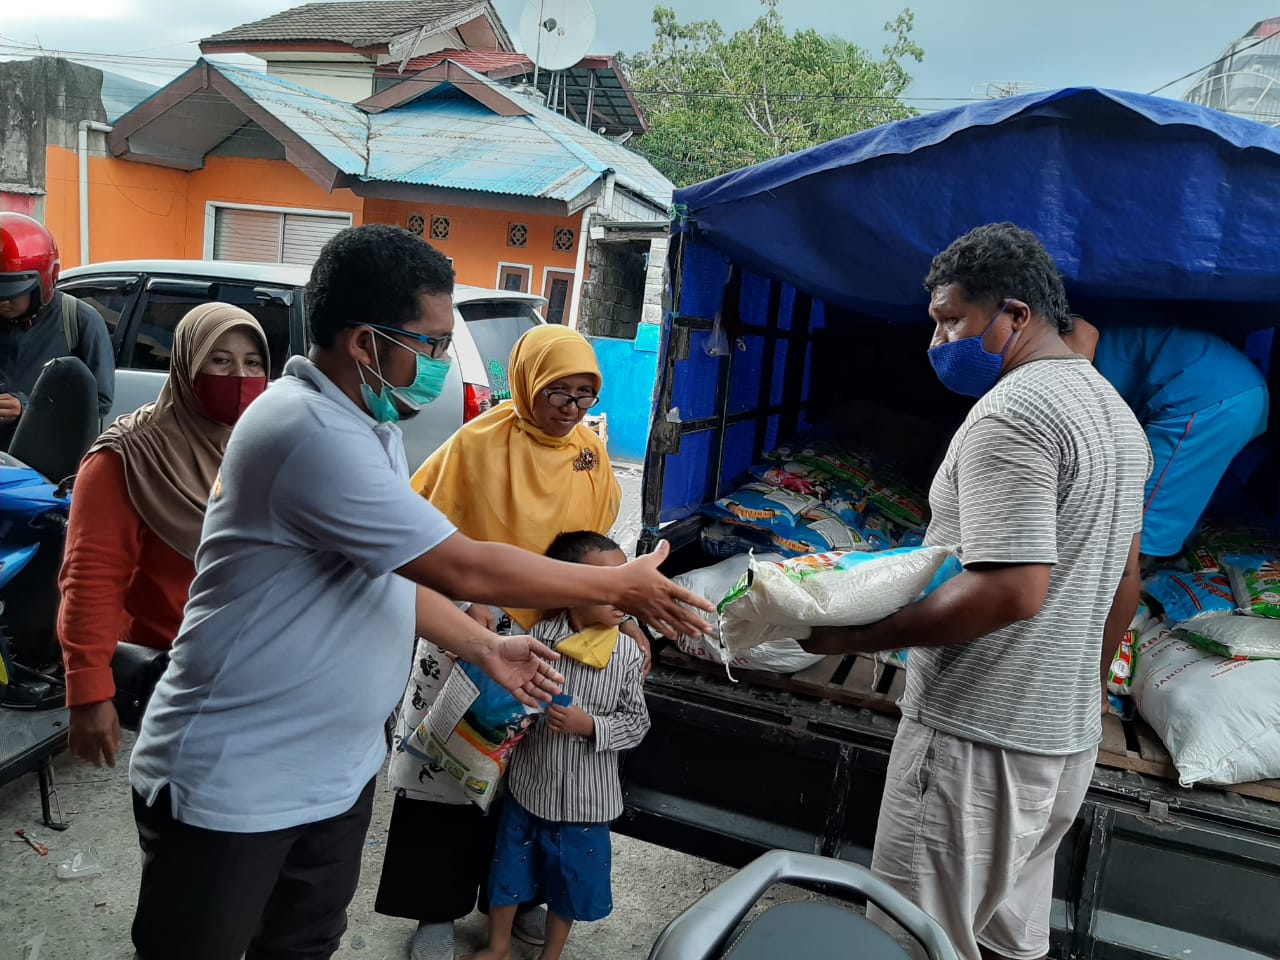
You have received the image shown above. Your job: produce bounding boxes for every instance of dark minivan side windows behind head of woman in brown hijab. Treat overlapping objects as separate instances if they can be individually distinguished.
[120,280,289,378]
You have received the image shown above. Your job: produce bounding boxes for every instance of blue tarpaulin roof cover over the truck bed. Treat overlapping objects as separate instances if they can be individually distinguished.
[675,88,1280,321]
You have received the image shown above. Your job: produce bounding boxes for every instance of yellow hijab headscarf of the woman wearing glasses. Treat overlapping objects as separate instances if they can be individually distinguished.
[412,324,622,630]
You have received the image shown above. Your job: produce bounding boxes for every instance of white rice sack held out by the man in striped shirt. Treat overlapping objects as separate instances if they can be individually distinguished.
[719,547,960,654]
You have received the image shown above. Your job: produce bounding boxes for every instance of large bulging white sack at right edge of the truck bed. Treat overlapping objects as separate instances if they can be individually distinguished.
[1133,622,1280,787]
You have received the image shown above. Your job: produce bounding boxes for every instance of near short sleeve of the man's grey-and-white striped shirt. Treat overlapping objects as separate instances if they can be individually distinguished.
[955,415,1061,566]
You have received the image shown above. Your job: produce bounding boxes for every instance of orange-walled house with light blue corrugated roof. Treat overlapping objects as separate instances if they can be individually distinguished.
[45,60,672,321]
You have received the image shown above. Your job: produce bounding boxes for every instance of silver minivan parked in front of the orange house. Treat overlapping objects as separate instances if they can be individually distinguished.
[58,260,547,470]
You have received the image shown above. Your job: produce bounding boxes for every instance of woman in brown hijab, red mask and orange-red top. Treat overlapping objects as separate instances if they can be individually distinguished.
[58,303,270,767]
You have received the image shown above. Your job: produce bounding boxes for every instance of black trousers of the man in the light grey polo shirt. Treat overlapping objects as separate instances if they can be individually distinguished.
[133,781,374,960]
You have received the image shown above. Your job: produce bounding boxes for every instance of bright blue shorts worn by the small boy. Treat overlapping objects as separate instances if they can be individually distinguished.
[489,796,613,920]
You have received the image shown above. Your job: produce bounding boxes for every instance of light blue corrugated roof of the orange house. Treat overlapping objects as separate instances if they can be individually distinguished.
[166,64,672,211]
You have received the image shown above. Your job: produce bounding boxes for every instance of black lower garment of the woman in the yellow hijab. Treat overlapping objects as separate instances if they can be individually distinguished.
[374,794,500,923]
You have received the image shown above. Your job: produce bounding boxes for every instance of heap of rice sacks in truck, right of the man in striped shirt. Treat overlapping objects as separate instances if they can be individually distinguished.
[1112,529,1280,786]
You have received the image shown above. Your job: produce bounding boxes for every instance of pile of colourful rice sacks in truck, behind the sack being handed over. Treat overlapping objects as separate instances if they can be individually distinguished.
[703,442,928,557]
